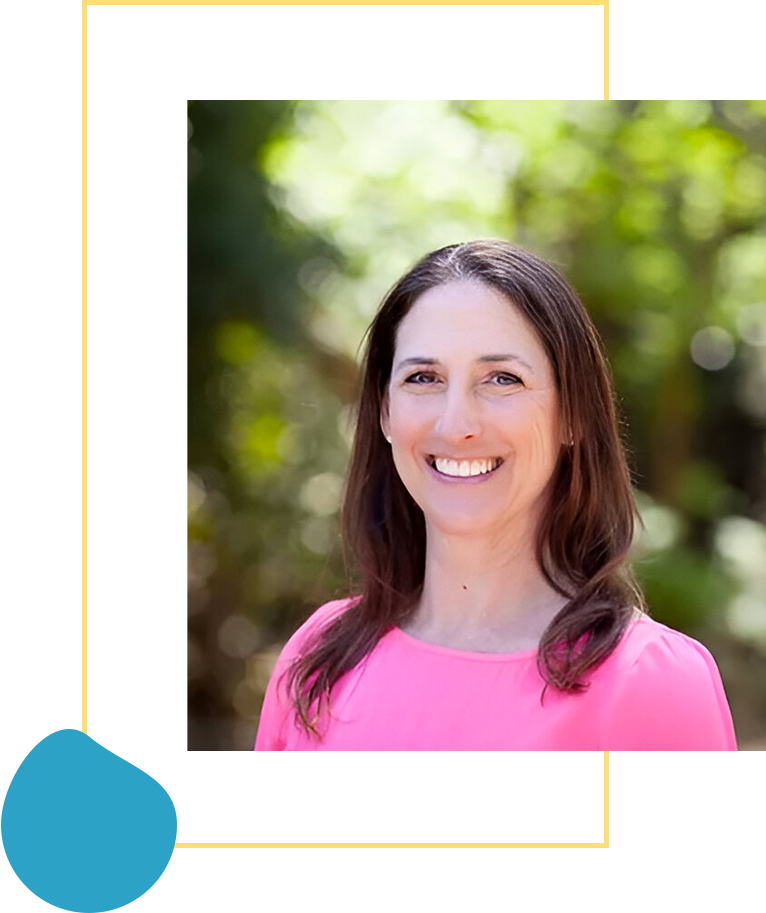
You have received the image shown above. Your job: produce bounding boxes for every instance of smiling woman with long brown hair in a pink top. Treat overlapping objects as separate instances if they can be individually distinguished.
[256,240,736,772]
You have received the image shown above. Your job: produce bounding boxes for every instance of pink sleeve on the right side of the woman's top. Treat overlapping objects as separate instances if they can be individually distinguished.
[603,628,737,751]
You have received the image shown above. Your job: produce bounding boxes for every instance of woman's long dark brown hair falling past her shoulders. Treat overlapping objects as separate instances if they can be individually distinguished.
[287,240,644,735]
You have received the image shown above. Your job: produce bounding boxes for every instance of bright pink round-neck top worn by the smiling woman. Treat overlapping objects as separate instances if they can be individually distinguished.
[256,599,737,751]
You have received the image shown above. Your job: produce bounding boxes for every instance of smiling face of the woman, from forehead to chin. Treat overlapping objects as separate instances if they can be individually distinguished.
[381,280,565,538]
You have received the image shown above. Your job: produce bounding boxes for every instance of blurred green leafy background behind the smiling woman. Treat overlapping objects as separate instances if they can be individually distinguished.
[187,101,766,750]
